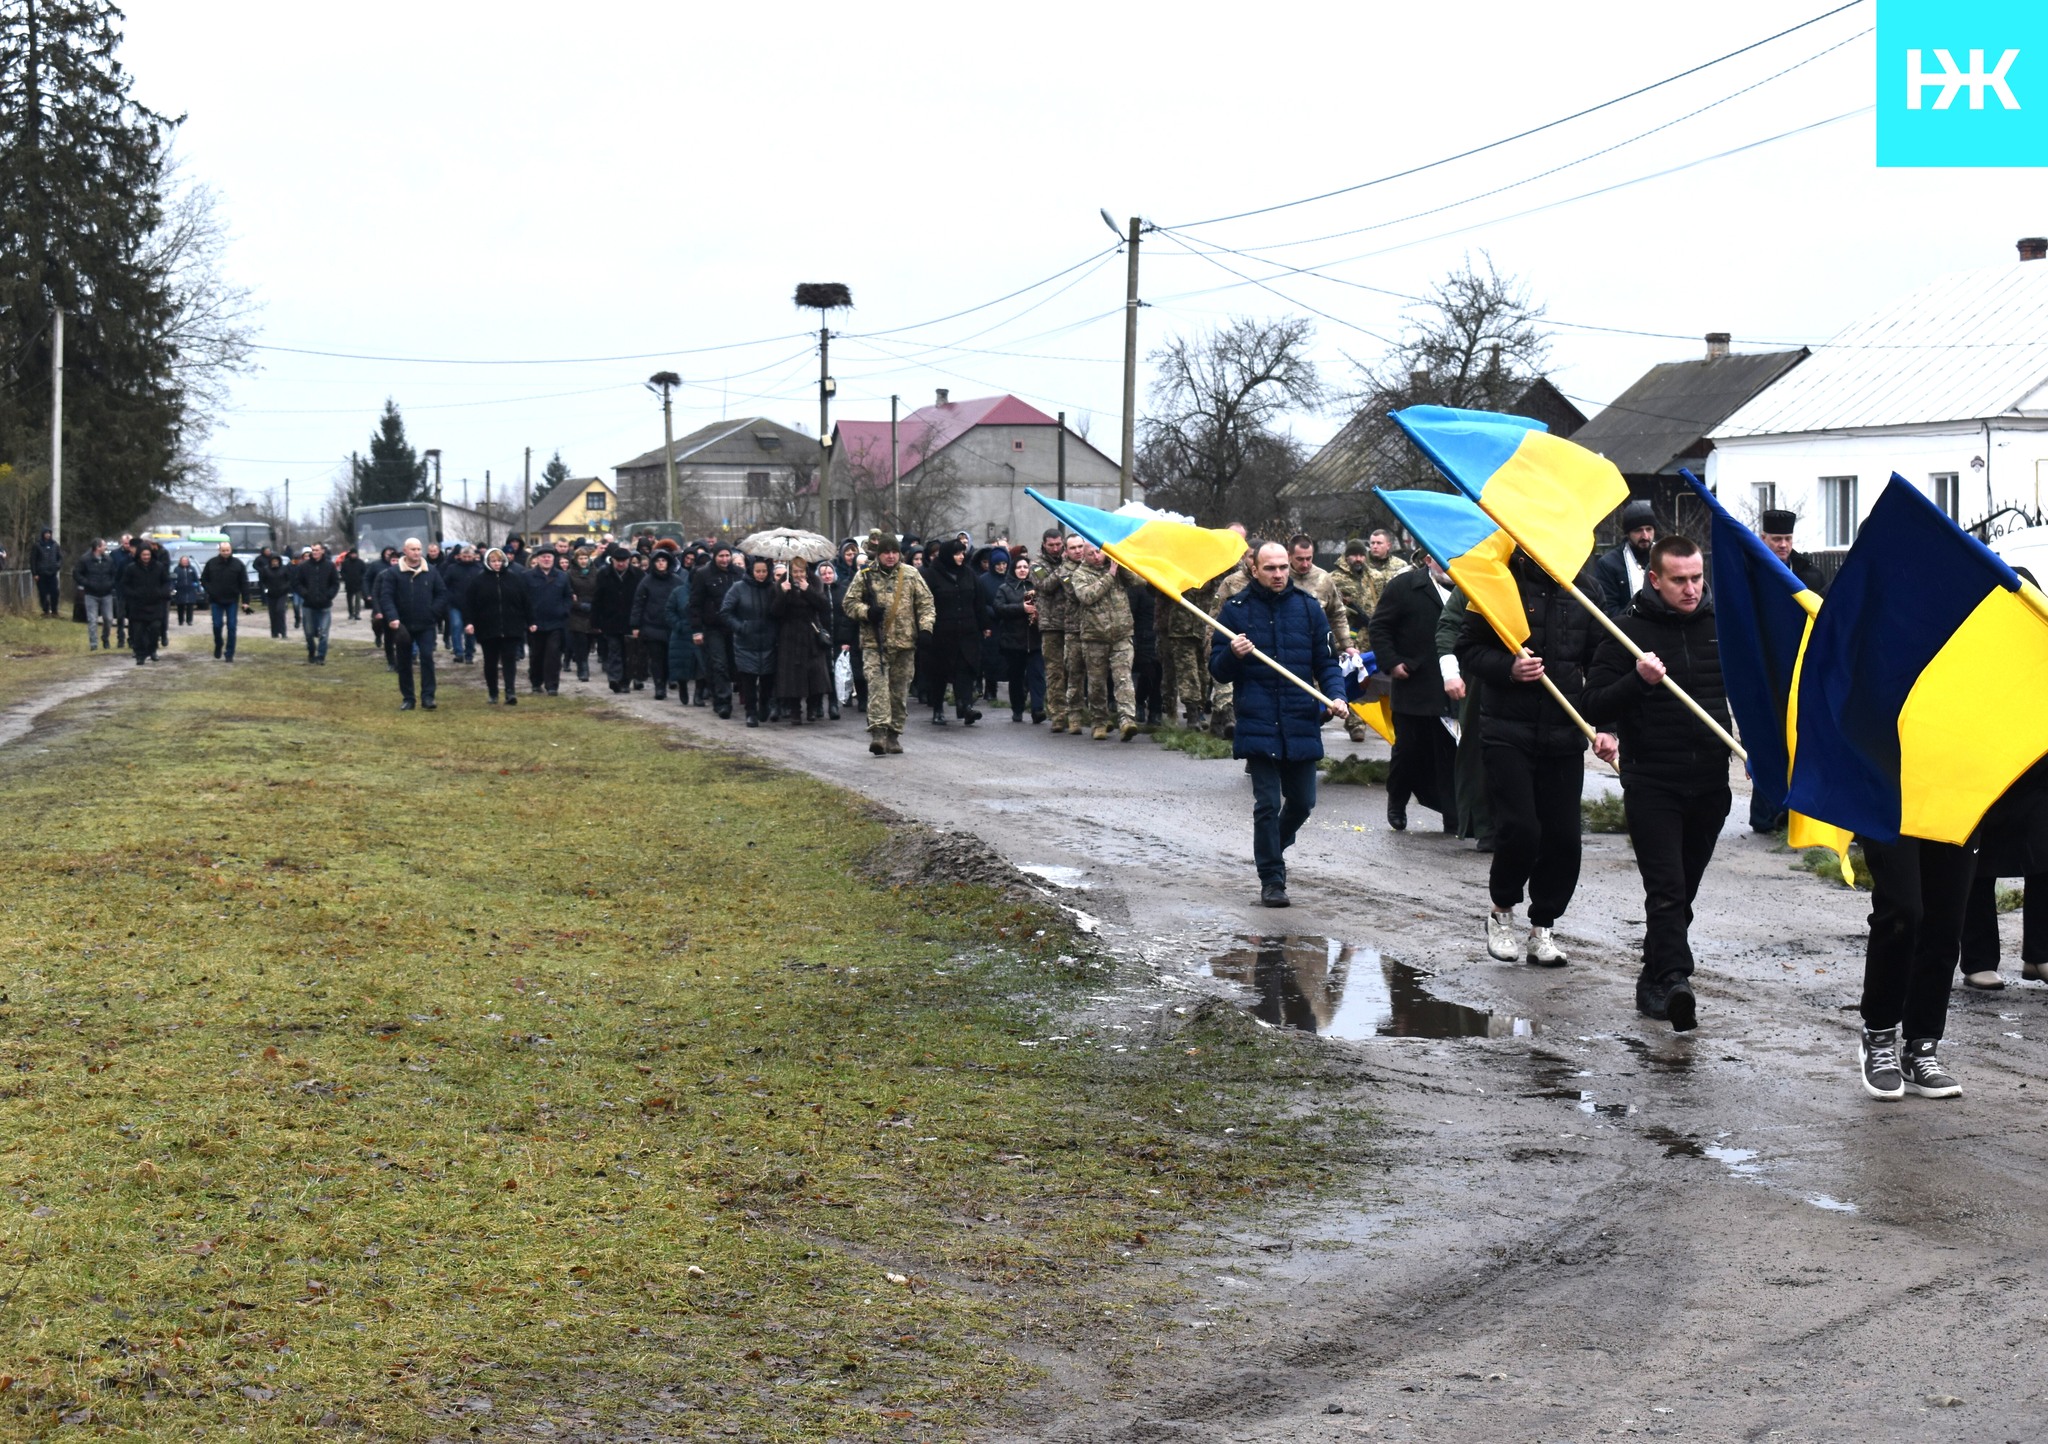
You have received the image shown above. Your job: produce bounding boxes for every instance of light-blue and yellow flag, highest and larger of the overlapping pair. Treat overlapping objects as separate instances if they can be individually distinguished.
[1393,406,1628,586]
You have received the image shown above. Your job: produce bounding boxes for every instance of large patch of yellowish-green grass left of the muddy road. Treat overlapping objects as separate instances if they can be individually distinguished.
[0,645,1370,1440]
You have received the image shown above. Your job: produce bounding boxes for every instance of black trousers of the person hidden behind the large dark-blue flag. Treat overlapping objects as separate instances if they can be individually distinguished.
[1858,838,1976,1038]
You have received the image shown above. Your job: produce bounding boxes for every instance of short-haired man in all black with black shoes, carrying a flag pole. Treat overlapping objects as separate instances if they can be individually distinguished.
[1585,537,1731,1032]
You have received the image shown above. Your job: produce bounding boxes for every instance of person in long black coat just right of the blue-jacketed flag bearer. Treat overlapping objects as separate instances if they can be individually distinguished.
[1366,557,1458,834]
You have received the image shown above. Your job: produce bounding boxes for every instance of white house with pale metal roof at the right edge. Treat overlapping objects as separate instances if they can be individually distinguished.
[1706,238,2048,549]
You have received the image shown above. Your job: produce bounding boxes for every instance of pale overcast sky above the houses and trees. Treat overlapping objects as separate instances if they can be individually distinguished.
[123,0,2048,514]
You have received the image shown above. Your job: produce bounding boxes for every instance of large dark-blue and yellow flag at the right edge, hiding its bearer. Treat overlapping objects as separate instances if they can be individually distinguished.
[1788,473,2048,844]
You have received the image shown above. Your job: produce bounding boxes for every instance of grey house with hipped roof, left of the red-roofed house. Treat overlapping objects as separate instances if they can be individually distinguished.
[612,416,819,535]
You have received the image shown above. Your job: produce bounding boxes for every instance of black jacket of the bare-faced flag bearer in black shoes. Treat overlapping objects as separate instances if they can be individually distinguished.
[1581,586,1731,793]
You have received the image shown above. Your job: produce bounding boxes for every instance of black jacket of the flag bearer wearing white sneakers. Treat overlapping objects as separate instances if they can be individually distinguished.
[1456,553,1606,756]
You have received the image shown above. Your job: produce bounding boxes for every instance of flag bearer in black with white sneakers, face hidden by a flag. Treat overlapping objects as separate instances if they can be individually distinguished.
[1456,551,1595,967]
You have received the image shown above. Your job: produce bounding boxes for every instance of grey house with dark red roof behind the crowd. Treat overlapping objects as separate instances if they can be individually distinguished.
[831,391,1143,543]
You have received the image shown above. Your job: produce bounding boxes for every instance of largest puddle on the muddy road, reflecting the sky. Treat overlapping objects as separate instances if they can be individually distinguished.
[1208,936,1534,1038]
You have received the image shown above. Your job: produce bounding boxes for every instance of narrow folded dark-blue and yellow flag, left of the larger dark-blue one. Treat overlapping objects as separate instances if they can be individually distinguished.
[1679,469,1855,883]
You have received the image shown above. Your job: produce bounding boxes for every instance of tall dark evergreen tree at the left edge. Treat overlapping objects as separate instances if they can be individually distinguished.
[0,0,184,535]
